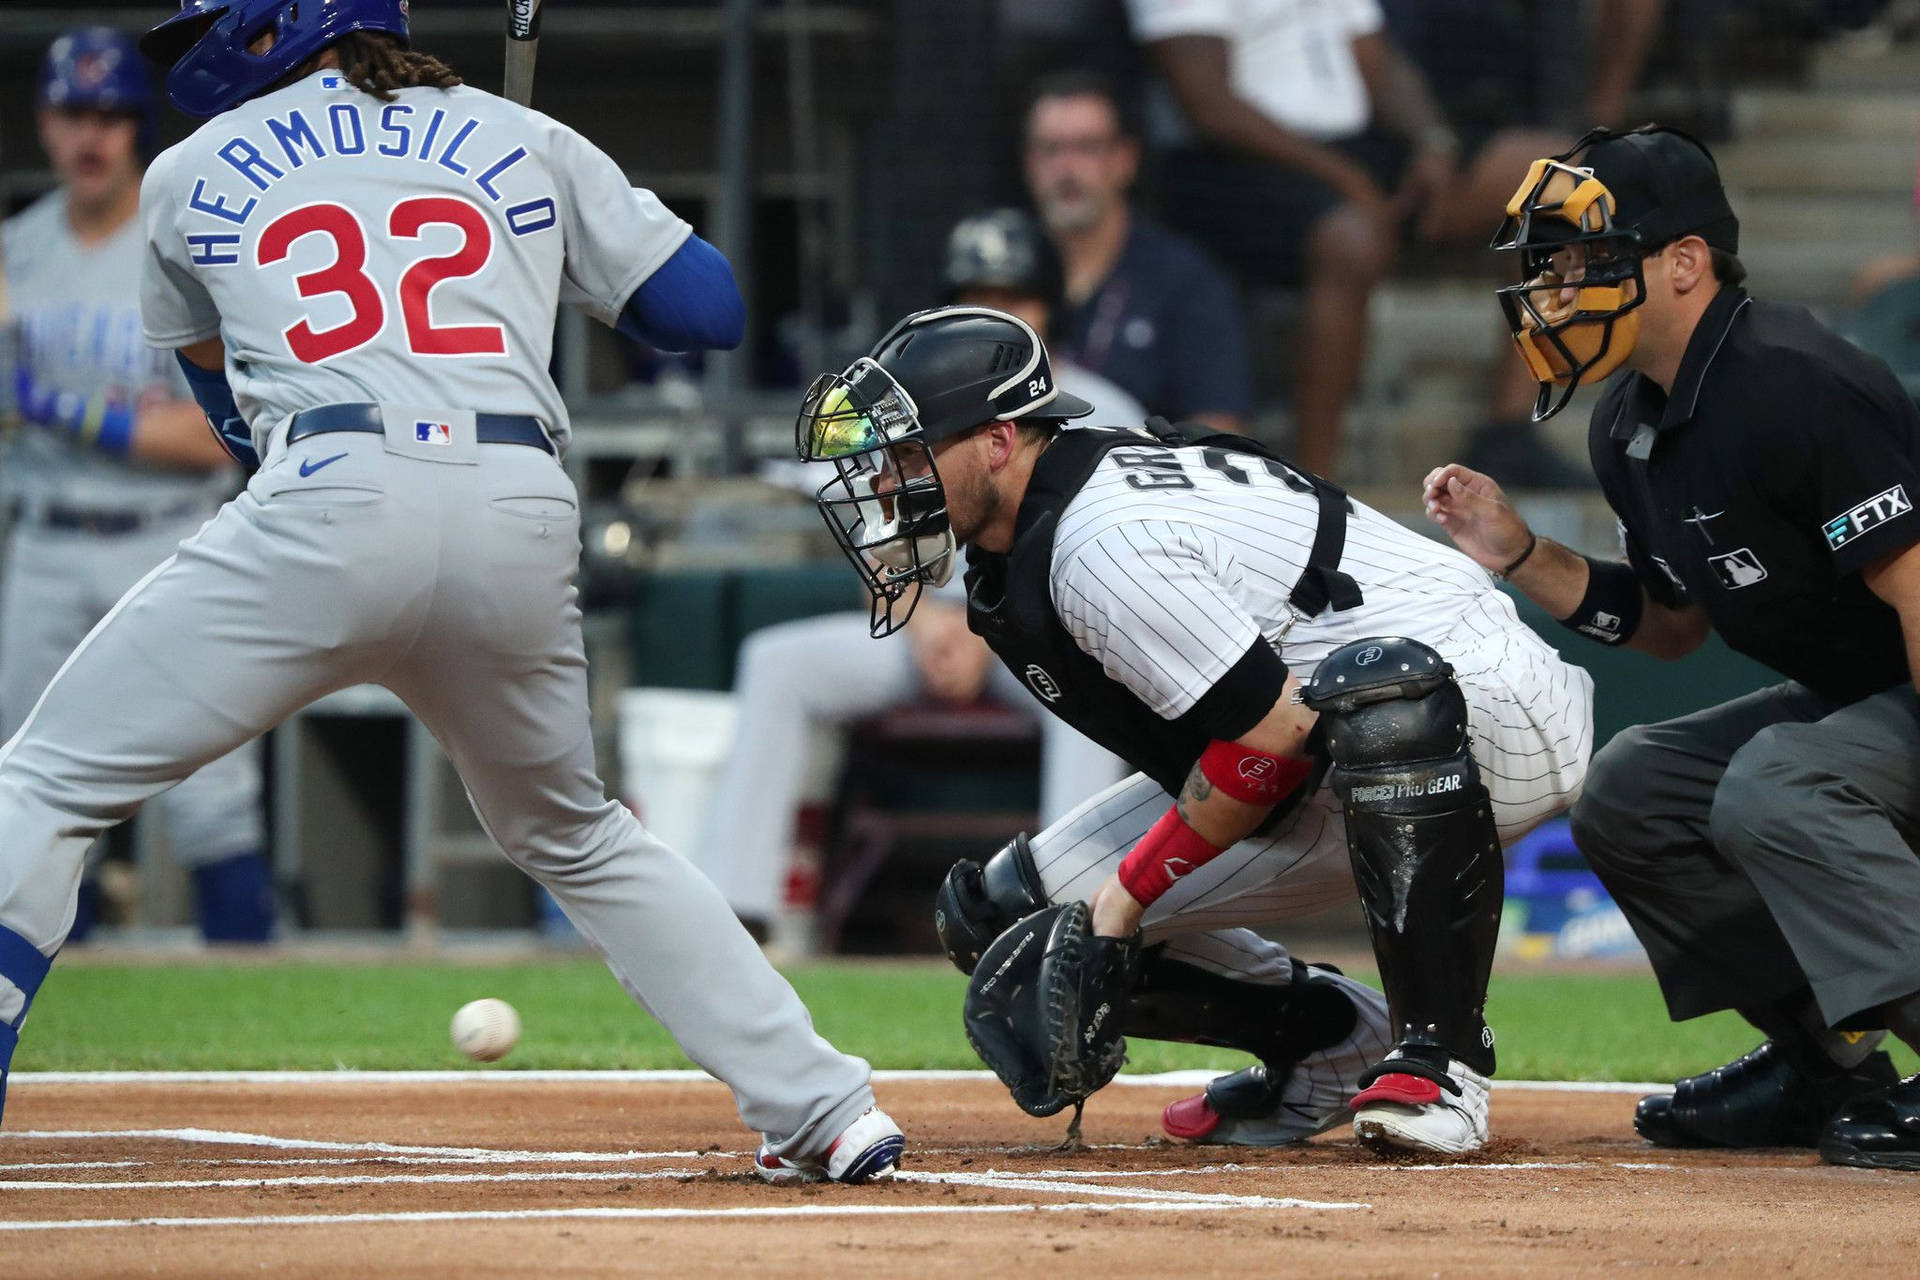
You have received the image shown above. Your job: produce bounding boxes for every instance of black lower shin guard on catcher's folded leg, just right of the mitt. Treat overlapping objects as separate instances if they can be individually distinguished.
[1119,946,1359,1117]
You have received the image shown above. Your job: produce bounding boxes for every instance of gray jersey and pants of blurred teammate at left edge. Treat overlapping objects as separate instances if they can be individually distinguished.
[0,192,265,867]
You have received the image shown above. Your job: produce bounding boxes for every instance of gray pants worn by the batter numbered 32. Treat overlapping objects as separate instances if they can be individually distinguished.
[0,426,874,1159]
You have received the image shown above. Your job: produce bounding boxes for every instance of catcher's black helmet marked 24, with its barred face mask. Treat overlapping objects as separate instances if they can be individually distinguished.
[795,307,1092,635]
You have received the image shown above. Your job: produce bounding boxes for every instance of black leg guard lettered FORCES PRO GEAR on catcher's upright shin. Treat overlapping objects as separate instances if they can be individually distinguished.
[1304,637,1505,1075]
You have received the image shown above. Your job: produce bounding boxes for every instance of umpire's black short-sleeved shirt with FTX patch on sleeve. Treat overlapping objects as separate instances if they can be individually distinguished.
[1588,288,1920,702]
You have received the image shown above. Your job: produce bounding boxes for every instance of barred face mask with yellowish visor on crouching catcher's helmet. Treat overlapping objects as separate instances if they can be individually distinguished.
[795,357,958,637]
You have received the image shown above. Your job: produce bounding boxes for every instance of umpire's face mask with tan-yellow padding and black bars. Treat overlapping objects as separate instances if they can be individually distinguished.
[1494,159,1647,422]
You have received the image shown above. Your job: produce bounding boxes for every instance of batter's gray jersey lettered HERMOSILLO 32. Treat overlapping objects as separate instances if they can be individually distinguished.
[140,71,691,451]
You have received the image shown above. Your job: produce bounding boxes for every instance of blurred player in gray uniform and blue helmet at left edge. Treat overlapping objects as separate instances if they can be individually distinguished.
[0,27,273,942]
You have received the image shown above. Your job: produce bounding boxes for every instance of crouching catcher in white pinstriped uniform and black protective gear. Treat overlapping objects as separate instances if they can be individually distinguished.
[799,307,1592,1153]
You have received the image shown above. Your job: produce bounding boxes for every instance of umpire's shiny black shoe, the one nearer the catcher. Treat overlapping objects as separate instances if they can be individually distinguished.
[1634,1040,1896,1151]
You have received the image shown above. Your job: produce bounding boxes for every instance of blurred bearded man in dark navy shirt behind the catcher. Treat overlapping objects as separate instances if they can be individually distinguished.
[1023,73,1252,432]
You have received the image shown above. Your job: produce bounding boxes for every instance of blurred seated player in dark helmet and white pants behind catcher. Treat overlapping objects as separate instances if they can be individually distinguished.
[699,209,1146,940]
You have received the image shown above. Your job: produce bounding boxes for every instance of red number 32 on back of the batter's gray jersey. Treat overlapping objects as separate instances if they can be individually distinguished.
[255,196,507,365]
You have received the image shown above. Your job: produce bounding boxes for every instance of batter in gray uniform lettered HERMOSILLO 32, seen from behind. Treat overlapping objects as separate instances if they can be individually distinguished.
[0,0,904,1182]
